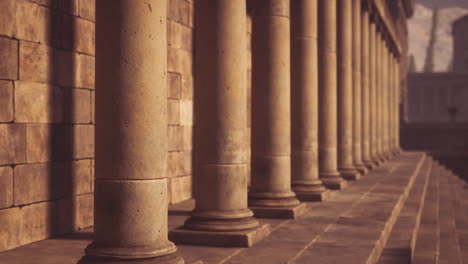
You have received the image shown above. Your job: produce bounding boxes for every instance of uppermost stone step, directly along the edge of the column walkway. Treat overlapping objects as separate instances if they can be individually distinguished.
[378,158,432,264]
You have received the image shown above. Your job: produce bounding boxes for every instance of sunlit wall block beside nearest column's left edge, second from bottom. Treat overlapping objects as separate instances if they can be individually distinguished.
[70,159,92,195]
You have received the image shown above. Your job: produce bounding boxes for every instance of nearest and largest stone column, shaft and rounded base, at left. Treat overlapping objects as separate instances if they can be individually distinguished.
[80,0,183,263]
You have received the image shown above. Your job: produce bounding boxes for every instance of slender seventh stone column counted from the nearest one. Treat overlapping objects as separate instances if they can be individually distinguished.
[352,1,367,175]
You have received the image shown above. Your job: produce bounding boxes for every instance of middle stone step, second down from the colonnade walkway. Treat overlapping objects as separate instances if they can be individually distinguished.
[412,164,441,264]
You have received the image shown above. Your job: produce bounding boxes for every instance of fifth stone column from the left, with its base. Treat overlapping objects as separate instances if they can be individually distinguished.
[318,0,347,189]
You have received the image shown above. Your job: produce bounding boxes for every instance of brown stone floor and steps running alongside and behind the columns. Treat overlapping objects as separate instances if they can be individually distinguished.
[0,152,468,264]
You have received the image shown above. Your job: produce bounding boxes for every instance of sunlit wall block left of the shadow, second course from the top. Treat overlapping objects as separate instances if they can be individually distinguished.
[19,41,53,83]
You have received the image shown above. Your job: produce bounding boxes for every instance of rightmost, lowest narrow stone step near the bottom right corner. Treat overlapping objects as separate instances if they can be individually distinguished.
[438,168,462,264]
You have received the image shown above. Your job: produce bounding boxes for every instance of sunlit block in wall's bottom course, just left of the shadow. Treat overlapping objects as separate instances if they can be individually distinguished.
[20,202,57,245]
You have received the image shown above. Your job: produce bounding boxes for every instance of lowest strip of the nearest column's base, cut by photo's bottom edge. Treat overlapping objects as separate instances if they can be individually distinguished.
[78,253,185,264]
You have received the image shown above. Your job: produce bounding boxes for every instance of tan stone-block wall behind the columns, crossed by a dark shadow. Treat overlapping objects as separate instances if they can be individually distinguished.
[0,0,193,251]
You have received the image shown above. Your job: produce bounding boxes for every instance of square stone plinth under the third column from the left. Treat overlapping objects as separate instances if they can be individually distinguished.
[249,203,307,219]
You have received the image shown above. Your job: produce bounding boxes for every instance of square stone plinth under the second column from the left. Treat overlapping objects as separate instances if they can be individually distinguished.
[169,224,271,247]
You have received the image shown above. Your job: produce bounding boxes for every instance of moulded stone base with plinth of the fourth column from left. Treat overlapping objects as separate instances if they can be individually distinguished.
[292,179,330,202]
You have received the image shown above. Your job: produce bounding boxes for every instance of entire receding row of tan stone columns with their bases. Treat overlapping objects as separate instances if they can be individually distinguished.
[81,0,400,263]
